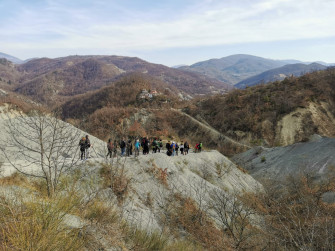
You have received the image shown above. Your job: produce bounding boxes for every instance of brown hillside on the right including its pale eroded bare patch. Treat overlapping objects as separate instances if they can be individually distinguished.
[185,68,335,145]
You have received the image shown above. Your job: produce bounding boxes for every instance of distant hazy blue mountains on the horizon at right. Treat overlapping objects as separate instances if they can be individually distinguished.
[179,54,332,88]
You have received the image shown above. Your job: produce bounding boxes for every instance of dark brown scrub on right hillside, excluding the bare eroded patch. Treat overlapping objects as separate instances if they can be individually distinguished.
[188,68,335,149]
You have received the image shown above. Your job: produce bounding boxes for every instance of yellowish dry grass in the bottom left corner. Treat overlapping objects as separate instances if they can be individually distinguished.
[0,191,85,250]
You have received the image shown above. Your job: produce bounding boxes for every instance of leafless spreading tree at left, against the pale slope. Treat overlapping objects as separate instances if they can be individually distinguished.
[1,110,80,196]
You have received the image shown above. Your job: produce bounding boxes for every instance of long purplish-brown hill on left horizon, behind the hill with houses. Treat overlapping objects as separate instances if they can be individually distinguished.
[16,56,232,103]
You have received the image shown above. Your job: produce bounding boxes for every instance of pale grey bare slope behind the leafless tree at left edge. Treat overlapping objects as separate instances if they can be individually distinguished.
[0,106,106,177]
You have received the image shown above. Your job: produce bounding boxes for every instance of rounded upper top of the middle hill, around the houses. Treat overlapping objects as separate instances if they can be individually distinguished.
[60,73,181,119]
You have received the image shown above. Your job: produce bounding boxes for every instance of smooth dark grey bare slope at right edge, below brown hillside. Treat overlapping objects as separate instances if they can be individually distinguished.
[232,135,335,181]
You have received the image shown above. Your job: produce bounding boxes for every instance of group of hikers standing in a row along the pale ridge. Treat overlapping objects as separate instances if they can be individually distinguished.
[79,135,202,160]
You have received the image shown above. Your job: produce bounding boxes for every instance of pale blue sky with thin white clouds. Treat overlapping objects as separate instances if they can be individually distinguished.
[0,0,335,66]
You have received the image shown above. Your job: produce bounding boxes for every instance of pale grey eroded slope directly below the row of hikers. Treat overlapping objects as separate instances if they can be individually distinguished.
[90,151,263,231]
